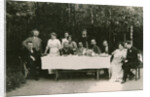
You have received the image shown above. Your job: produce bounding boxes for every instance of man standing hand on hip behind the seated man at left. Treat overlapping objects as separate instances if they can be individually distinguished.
[22,29,42,54]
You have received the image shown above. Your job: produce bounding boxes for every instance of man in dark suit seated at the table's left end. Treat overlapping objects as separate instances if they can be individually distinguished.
[23,41,41,80]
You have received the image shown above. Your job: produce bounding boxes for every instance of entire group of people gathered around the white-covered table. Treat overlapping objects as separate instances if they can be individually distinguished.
[22,30,142,83]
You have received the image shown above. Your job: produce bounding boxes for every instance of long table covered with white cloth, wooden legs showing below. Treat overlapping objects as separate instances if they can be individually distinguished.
[42,56,110,80]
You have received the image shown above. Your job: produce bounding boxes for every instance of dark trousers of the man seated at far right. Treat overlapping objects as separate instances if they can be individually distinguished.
[122,61,138,81]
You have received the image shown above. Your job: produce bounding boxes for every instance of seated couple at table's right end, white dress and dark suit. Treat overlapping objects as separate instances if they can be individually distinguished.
[110,41,140,83]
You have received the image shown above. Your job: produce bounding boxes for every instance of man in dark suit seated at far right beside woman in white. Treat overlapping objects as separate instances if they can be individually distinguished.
[122,41,139,83]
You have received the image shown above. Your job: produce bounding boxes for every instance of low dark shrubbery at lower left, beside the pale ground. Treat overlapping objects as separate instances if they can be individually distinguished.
[6,55,25,92]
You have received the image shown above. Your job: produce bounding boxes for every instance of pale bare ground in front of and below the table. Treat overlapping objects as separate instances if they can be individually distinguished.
[6,69,143,96]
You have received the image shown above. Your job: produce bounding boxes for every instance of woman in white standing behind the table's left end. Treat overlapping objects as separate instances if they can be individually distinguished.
[45,32,61,74]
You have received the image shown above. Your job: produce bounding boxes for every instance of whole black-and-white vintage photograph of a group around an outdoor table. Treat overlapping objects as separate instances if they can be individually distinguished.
[5,0,143,96]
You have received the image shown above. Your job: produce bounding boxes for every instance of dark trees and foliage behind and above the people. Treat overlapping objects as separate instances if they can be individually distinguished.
[6,1,143,52]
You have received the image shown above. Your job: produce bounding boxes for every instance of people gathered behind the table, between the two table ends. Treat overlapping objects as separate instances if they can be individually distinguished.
[44,30,108,56]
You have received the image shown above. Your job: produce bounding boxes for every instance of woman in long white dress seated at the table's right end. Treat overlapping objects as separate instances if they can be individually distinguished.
[110,43,127,82]
